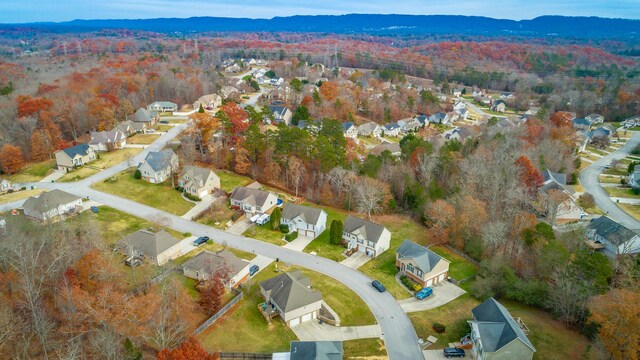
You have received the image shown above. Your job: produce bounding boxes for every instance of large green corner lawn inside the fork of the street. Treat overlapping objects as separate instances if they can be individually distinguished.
[93,169,193,215]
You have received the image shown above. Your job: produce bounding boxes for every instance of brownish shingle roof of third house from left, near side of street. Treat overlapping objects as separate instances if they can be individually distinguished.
[182,250,249,281]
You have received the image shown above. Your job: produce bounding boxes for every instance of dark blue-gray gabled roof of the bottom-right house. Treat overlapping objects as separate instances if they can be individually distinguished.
[471,298,536,352]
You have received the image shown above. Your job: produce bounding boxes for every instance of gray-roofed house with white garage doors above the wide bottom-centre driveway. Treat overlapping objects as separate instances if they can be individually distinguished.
[260,270,322,327]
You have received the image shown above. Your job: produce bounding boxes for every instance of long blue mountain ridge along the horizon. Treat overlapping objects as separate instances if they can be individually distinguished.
[0,14,640,38]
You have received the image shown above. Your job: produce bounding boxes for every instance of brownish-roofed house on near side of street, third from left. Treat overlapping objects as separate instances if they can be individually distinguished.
[182,250,249,287]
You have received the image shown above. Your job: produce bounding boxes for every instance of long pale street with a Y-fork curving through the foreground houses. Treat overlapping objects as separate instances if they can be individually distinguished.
[6,120,424,360]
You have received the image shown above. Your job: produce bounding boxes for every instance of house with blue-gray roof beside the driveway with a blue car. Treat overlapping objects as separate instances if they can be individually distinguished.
[396,240,449,287]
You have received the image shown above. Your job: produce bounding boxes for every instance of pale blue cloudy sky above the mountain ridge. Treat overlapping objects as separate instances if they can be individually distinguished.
[0,0,640,23]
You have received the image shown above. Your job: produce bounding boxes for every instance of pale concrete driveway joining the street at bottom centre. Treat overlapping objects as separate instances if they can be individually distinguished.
[291,320,382,341]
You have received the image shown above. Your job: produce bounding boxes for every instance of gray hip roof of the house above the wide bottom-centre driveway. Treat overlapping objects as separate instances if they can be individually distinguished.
[260,270,322,312]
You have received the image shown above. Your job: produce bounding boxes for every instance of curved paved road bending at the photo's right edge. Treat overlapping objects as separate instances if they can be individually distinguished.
[580,132,640,230]
